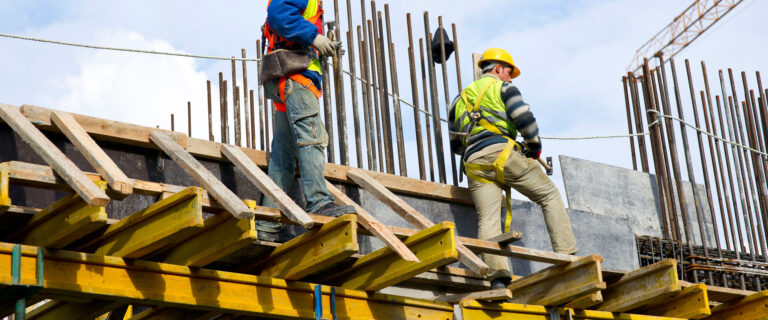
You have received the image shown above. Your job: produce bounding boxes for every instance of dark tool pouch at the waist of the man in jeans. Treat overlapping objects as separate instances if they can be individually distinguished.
[259,49,312,83]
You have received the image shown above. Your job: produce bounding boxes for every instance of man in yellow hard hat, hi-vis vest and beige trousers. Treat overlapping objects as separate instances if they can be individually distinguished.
[448,48,576,288]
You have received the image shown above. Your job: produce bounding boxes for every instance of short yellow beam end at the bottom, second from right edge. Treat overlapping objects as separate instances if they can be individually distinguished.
[632,283,712,319]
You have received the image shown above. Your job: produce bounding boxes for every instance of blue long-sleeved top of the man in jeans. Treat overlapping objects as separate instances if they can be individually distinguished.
[267,0,322,89]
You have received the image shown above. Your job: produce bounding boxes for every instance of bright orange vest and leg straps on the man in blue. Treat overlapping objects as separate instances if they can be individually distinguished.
[263,0,323,112]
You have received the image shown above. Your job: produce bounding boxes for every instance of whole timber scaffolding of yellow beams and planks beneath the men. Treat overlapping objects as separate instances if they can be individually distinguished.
[0,104,768,320]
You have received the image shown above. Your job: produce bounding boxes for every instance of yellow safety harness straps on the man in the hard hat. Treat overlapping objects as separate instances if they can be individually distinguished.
[461,81,522,233]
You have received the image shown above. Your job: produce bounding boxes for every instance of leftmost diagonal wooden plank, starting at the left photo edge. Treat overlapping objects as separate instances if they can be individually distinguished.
[0,103,109,207]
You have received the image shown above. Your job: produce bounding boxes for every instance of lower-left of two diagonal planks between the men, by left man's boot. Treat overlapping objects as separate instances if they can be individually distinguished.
[325,181,419,262]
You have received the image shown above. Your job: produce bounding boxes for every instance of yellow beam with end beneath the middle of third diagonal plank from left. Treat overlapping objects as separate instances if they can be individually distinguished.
[94,187,203,258]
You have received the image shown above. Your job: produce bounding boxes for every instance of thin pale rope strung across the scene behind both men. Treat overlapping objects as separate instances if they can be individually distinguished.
[0,33,768,156]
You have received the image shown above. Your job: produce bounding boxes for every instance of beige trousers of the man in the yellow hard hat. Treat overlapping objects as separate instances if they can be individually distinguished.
[467,144,576,280]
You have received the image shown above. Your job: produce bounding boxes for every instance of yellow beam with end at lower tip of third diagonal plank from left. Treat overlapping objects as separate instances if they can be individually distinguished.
[163,200,257,267]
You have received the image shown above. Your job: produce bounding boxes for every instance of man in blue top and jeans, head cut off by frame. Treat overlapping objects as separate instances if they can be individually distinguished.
[256,0,355,241]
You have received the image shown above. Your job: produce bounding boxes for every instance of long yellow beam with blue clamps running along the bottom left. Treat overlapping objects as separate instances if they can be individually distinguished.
[0,242,455,320]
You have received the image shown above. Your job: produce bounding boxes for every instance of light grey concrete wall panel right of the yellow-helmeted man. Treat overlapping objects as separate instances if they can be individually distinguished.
[560,155,714,246]
